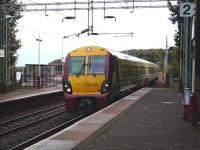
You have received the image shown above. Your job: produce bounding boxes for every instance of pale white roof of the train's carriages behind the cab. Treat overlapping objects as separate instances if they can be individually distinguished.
[108,49,157,66]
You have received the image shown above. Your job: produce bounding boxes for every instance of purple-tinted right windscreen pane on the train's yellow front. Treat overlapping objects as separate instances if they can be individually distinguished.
[88,56,106,74]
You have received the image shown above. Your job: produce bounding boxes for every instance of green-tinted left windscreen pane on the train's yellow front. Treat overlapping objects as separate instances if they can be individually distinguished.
[69,57,85,75]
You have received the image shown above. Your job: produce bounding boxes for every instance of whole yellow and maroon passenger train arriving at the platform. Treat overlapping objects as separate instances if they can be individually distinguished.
[63,46,159,112]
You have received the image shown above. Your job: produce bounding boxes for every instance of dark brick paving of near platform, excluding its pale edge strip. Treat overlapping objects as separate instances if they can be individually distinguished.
[73,88,200,150]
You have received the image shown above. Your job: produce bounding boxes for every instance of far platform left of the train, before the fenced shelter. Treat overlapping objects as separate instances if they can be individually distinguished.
[0,84,62,103]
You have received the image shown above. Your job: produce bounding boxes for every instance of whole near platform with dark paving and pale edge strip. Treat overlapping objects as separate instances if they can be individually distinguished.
[27,88,200,150]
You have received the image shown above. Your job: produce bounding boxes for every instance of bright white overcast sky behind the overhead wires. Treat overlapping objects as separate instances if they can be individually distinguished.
[16,0,177,66]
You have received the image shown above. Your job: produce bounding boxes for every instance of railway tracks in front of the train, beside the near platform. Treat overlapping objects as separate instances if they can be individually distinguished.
[0,104,83,150]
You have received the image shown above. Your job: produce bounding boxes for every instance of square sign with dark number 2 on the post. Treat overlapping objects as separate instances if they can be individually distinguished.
[180,2,196,17]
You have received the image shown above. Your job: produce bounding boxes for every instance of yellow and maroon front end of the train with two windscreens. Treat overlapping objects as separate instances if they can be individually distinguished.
[63,48,110,112]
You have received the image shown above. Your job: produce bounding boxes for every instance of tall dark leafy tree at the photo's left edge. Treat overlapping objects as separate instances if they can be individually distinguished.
[0,0,21,93]
